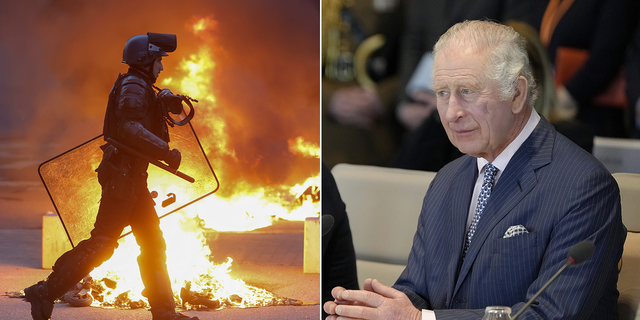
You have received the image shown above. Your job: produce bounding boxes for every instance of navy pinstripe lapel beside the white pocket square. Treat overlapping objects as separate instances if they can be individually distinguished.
[453,118,555,295]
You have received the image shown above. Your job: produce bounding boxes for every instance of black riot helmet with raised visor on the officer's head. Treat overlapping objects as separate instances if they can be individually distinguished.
[122,32,178,66]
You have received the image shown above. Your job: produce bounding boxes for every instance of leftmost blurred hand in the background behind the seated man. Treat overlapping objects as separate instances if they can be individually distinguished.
[329,87,384,129]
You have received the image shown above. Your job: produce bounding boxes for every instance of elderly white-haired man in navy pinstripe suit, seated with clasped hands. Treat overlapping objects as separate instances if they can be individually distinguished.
[324,21,626,320]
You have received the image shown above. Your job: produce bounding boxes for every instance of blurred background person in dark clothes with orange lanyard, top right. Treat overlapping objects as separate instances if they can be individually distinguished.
[540,0,640,138]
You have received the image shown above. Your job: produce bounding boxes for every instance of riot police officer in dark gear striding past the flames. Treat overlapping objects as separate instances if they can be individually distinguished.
[24,33,198,320]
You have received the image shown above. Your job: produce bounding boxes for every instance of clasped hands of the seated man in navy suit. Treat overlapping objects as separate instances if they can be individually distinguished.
[324,279,422,320]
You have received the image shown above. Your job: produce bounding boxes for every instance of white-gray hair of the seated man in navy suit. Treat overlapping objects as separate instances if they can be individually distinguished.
[433,20,538,108]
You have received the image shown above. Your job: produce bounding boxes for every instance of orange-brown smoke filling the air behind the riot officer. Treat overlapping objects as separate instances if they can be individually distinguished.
[0,0,320,195]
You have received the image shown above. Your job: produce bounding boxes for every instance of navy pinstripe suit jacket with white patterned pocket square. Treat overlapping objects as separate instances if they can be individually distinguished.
[394,118,626,320]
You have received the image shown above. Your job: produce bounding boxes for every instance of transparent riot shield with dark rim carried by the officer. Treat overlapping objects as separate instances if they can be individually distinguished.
[38,123,220,246]
